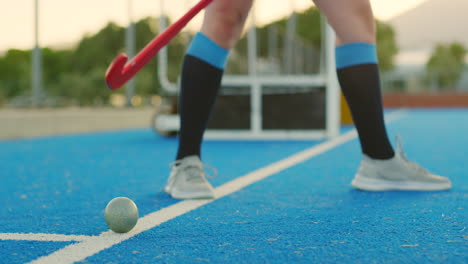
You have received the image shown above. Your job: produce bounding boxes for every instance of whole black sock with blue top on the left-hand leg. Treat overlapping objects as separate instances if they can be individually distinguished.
[176,33,229,159]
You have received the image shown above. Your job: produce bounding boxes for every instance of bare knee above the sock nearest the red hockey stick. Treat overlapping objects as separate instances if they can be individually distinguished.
[201,0,252,49]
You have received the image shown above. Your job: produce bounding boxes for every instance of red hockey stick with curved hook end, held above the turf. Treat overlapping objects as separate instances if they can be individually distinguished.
[106,0,213,90]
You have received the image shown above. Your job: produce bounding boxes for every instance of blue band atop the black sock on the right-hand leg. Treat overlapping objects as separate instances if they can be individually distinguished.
[335,42,378,69]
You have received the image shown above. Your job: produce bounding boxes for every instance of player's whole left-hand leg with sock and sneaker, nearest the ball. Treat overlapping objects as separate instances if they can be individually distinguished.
[165,0,252,199]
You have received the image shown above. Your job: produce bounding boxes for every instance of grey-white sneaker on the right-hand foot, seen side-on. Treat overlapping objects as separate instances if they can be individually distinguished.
[351,137,452,191]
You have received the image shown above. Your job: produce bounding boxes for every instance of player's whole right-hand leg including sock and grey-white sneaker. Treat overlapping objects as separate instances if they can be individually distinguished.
[314,0,451,190]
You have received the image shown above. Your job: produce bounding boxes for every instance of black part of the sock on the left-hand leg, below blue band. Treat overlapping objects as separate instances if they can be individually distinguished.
[176,55,223,159]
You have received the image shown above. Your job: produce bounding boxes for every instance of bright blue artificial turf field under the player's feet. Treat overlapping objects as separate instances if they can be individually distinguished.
[0,109,468,263]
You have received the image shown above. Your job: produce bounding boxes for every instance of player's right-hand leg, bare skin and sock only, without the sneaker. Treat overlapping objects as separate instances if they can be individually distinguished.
[315,0,394,159]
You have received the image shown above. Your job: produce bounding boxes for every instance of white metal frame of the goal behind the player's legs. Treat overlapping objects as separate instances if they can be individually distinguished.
[155,1,340,139]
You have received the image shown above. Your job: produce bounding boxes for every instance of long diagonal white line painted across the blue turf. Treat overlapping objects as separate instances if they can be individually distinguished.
[20,110,405,264]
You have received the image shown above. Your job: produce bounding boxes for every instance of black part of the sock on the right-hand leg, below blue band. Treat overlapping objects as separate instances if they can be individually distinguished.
[337,63,395,159]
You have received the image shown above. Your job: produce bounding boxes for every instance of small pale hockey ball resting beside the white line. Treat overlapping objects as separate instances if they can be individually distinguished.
[104,197,138,233]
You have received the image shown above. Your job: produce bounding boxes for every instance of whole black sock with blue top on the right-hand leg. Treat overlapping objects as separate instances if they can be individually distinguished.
[336,42,395,159]
